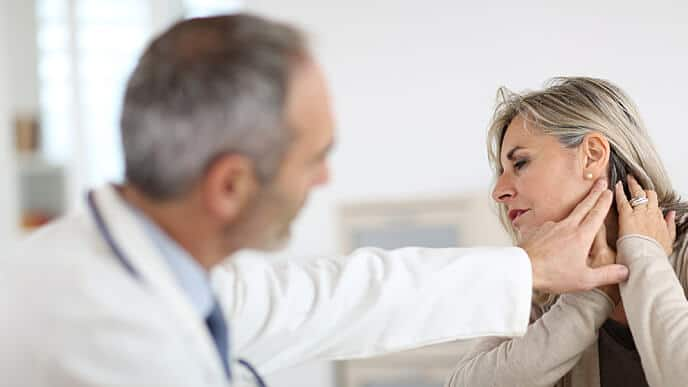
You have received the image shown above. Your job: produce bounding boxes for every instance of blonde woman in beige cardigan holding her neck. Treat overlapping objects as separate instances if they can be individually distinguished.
[448,78,688,387]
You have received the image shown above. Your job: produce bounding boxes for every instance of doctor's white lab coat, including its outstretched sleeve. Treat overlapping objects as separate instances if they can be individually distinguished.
[0,187,531,387]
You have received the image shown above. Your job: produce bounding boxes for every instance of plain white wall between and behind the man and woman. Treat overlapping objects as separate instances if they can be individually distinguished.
[243,0,688,387]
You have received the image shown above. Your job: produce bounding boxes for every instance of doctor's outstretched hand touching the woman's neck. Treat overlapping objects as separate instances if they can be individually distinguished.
[519,179,628,294]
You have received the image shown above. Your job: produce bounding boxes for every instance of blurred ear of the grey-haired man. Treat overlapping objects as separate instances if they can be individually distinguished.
[202,154,258,221]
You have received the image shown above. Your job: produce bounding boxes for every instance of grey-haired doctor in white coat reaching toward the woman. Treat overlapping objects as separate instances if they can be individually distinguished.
[0,15,627,387]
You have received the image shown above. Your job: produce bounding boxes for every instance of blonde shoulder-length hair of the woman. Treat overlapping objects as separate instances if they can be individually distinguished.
[487,77,688,306]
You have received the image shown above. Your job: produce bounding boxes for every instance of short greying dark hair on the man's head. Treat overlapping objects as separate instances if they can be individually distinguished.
[121,14,308,199]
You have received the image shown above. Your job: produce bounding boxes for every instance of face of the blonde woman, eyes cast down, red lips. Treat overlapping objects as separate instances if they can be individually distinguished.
[492,115,600,238]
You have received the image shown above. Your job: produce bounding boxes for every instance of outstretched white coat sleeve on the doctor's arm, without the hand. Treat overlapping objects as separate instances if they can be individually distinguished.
[213,247,532,373]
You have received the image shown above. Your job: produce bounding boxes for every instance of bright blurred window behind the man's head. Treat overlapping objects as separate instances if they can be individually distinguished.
[36,0,243,205]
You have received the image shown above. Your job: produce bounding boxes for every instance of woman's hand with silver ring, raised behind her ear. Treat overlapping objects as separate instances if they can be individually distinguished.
[615,175,676,256]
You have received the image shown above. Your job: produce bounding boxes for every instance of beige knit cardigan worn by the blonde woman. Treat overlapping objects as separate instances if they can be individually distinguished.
[447,235,688,387]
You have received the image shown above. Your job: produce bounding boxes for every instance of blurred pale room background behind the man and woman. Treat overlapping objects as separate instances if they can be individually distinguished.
[0,0,688,387]
